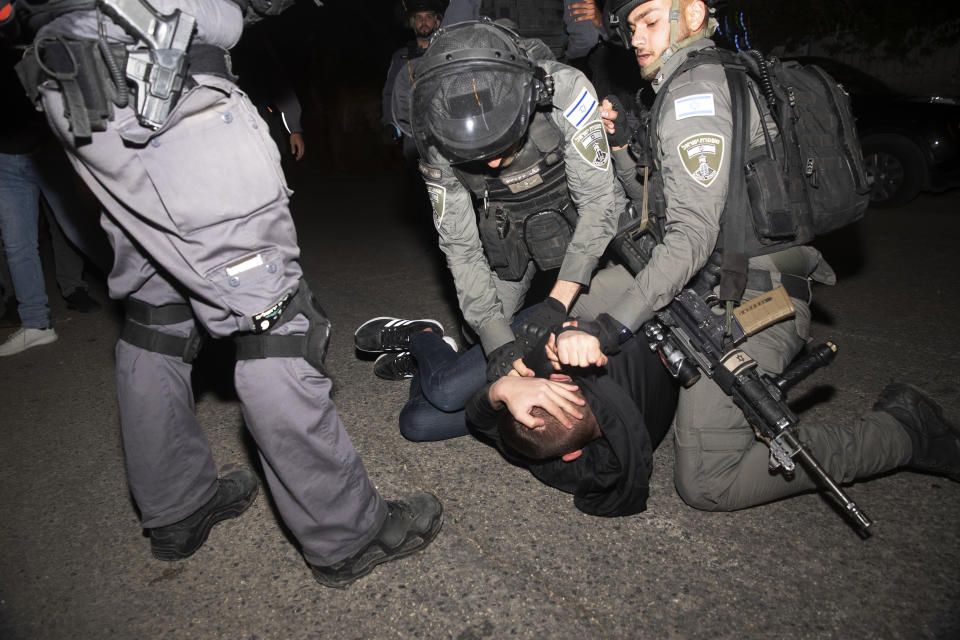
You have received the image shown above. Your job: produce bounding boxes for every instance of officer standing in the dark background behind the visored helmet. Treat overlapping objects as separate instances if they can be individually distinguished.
[380,0,447,160]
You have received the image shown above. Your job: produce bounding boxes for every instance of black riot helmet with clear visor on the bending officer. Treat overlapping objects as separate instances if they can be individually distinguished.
[410,18,549,163]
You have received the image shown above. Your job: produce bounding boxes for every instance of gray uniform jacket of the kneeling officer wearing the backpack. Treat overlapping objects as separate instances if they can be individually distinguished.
[610,40,833,331]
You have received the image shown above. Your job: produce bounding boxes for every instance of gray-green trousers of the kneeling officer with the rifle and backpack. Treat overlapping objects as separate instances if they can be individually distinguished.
[574,265,913,511]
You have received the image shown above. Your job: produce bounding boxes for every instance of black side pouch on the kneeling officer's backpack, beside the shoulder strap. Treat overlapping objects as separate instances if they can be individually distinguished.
[744,153,797,243]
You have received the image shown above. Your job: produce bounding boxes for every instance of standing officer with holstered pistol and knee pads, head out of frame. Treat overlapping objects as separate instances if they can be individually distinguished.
[17,0,442,587]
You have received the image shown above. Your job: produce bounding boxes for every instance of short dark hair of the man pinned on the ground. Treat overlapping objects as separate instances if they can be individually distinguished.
[497,396,601,460]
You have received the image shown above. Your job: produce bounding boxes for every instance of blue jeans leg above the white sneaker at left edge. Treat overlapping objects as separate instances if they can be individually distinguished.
[0,153,50,329]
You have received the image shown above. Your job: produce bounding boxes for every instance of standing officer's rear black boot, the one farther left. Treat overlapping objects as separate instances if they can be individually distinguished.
[150,469,260,561]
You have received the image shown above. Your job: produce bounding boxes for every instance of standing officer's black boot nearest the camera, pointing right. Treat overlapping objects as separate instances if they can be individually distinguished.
[310,492,443,589]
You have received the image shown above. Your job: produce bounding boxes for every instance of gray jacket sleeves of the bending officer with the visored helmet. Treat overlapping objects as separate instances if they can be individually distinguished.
[421,61,626,353]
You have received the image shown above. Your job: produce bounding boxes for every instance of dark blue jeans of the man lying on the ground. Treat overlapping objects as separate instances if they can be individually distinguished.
[400,306,536,442]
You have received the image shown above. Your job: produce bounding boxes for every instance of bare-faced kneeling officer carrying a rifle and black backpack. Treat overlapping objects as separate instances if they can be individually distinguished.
[603,0,960,511]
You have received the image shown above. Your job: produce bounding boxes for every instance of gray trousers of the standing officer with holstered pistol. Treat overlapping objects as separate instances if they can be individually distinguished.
[42,76,386,565]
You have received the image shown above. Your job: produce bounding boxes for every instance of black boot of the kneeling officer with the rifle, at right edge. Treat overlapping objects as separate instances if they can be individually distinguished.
[873,382,960,482]
